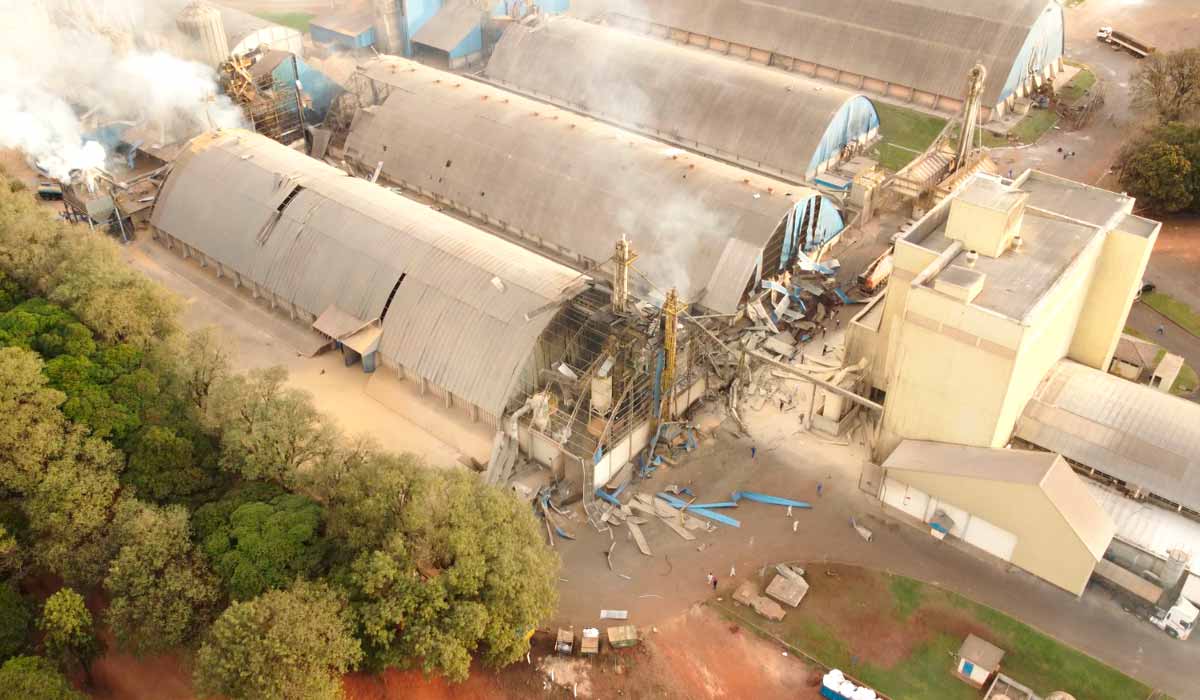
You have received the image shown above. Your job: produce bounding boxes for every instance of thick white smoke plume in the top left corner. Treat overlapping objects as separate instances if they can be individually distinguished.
[0,0,242,179]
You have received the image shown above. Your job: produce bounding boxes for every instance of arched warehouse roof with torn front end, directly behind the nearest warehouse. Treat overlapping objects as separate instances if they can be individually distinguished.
[346,56,842,312]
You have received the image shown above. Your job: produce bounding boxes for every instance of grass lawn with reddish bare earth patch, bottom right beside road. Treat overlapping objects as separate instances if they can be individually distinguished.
[732,564,1151,700]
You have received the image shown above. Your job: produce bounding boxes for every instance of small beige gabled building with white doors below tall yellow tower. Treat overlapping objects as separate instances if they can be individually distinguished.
[880,439,1116,596]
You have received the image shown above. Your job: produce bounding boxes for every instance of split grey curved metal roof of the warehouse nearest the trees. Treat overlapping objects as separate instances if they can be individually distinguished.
[151,130,580,415]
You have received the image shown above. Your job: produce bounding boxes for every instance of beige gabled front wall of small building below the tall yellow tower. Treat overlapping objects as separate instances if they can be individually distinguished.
[888,469,1096,596]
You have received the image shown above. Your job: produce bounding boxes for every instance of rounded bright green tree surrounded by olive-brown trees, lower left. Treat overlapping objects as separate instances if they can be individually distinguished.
[203,493,328,600]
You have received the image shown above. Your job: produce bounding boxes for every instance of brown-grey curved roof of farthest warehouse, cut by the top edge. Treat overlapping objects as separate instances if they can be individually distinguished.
[585,0,1062,104]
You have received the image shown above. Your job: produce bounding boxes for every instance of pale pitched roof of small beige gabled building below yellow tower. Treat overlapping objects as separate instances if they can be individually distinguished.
[883,439,1116,560]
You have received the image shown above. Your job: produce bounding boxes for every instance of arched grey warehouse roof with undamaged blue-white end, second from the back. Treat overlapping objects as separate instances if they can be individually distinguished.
[486,17,880,180]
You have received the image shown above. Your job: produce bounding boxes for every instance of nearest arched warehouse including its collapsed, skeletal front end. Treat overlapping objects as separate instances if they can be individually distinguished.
[151,130,707,487]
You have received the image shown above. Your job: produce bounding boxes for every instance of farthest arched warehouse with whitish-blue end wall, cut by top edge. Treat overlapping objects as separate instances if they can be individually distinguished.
[571,0,1064,116]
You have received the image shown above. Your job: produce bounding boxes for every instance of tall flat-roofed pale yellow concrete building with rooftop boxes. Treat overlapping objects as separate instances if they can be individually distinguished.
[846,170,1160,461]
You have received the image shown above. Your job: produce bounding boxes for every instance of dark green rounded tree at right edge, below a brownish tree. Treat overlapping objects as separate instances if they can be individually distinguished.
[1121,137,1193,214]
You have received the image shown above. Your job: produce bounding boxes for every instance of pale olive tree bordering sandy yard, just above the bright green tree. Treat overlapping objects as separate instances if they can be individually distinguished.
[208,367,338,484]
